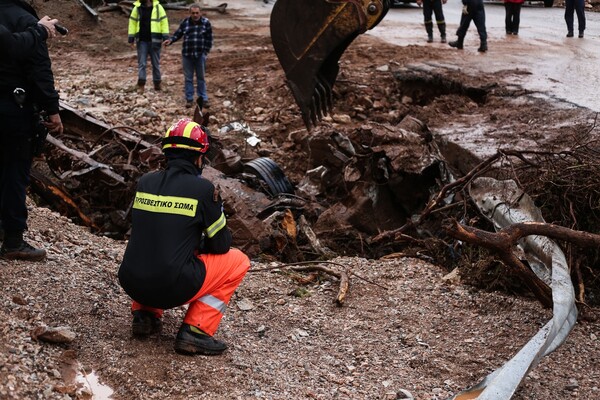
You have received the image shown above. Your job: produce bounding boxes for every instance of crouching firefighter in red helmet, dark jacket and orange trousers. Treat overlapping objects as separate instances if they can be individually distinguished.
[119,119,250,355]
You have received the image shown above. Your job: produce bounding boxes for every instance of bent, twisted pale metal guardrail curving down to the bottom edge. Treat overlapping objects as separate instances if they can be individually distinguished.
[452,178,577,400]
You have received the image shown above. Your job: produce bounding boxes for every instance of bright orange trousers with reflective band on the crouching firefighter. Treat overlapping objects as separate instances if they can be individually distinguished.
[131,249,250,336]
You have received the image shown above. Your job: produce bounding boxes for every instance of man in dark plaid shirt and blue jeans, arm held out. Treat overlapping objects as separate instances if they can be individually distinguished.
[163,4,213,108]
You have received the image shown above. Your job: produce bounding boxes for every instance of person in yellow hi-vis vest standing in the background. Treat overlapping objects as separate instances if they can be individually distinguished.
[127,0,169,93]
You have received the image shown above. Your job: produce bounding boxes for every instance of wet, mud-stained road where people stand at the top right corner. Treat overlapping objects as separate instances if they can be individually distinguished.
[369,0,600,112]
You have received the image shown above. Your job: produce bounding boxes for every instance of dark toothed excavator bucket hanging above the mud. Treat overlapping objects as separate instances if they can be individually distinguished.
[271,0,391,130]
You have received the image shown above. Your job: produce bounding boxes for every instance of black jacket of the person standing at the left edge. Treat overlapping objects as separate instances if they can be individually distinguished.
[0,0,59,114]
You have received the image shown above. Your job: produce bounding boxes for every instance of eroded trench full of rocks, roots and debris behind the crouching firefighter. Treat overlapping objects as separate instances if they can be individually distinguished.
[32,71,524,262]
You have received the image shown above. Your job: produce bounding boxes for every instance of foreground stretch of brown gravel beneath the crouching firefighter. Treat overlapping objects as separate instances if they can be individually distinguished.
[0,205,600,399]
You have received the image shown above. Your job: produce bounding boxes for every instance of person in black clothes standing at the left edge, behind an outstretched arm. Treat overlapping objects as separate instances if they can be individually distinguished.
[0,0,63,261]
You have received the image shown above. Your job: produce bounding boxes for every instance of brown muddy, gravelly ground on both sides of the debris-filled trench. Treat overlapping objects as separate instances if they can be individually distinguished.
[0,0,600,399]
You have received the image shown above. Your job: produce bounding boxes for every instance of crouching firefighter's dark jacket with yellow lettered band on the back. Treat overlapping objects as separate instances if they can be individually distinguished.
[119,159,232,309]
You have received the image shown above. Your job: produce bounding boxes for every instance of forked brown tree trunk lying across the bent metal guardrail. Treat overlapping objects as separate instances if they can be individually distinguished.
[444,219,600,308]
